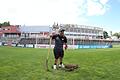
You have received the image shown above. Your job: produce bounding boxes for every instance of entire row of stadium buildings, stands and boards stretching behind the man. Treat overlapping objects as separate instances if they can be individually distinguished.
[0,24,120,49]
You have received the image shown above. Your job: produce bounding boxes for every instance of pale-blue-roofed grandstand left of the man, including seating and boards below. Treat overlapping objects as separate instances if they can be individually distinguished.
[18,25,50,48]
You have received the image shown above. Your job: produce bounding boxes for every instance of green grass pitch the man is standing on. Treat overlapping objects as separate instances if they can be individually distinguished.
[0,47,120,80]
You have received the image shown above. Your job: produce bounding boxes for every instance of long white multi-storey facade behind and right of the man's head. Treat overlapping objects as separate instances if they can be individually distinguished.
[53,24,103,39]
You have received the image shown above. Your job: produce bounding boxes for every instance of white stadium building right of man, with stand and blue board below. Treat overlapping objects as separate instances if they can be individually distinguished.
[52,24,112,48]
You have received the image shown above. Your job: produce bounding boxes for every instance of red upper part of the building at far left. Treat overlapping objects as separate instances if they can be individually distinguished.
[2,26,20,33]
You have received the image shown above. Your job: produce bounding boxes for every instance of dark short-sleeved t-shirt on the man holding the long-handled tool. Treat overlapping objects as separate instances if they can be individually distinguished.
[52,34,67,50]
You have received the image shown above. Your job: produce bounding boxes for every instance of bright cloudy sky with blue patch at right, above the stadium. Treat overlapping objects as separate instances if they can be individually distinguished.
[0,0,120,32]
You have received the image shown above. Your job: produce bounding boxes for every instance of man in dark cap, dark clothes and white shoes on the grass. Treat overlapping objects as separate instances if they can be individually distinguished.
[51,29,67,69]
